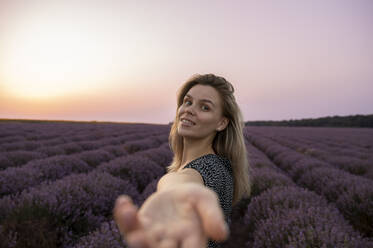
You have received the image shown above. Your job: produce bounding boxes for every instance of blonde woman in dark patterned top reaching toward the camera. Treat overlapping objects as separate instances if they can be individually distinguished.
[113,74,250,248]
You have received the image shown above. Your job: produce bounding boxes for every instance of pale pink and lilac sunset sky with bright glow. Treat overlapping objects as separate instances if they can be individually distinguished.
[0,0,373,124]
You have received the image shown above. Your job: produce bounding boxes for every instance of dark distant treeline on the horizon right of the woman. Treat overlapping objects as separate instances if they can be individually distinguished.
[245,114,373,127]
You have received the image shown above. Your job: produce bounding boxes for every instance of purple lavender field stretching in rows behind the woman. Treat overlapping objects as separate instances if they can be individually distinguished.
[0,122,373,248]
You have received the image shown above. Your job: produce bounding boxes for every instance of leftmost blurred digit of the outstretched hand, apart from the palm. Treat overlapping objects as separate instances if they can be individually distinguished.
[113,195,141,235]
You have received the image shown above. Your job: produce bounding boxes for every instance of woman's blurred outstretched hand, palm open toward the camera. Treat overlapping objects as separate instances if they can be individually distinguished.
[113,183,229,248]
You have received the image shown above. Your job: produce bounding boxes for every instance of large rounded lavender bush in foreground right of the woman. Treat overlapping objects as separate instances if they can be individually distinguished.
[244,187,368,247]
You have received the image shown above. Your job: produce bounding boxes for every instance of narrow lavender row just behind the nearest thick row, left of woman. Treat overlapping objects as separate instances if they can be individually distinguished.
[0,134,168,197]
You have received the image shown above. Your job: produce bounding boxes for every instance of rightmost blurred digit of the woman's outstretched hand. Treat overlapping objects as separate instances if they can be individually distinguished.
[190,188,229,241]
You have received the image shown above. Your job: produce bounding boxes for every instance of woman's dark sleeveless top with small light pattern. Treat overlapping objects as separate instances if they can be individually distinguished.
[183,154,234,248]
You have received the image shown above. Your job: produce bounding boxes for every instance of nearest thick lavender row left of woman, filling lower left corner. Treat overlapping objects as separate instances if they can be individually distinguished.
[0,129,171,247]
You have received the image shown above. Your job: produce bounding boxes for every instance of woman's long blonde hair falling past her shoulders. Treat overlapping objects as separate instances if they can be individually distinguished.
[167,74,251,205]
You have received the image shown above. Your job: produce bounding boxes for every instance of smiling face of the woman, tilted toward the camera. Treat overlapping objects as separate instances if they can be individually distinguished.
[177,84,228,138]
